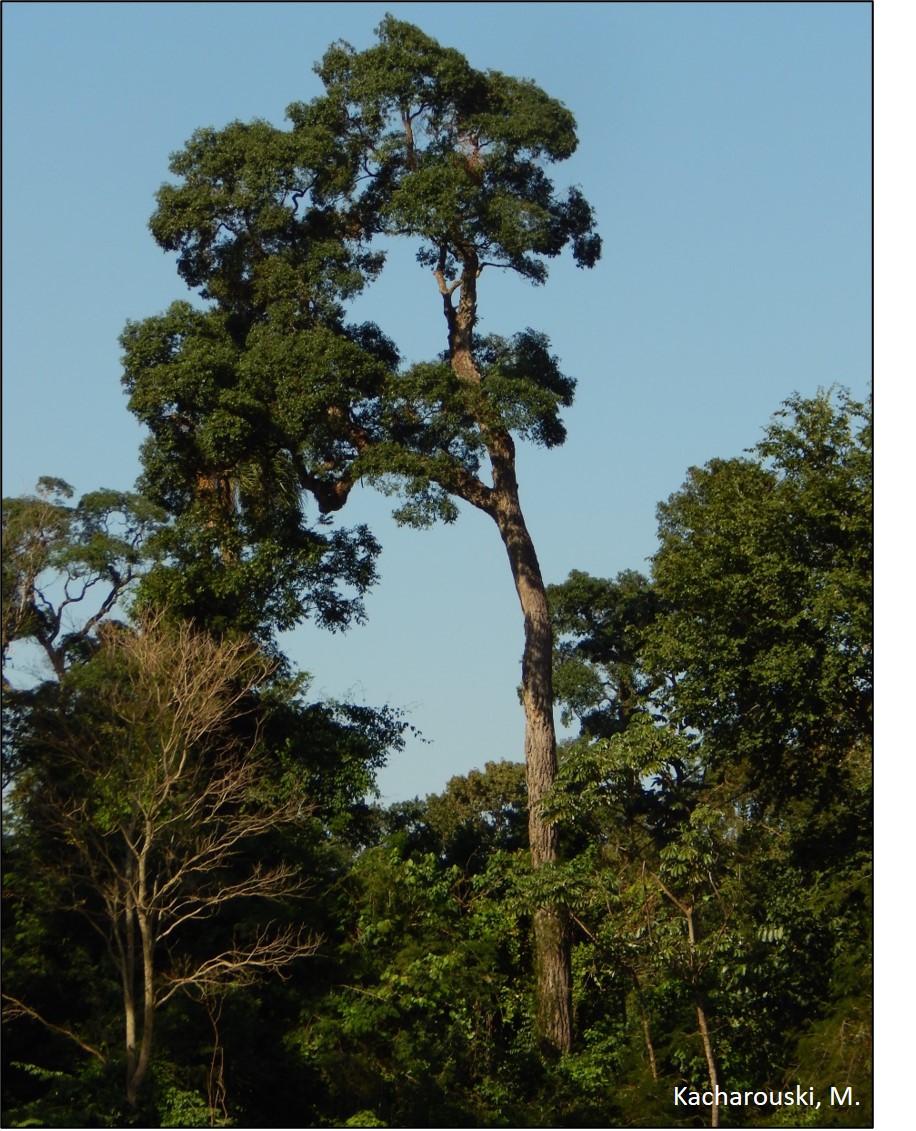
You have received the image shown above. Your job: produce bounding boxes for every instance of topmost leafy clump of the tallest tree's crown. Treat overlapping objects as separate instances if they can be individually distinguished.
[287,16,600,283]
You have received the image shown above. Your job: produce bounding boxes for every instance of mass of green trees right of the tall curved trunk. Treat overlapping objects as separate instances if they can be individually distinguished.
[542,394,872,1123]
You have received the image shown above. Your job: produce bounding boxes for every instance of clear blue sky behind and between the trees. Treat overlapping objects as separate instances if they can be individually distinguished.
[3,2,872,800]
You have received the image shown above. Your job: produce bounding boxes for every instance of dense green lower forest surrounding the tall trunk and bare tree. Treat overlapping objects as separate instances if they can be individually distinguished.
[5,386,871,1126]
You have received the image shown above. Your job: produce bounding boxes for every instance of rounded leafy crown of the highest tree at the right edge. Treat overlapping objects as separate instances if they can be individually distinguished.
[650,397,872,801]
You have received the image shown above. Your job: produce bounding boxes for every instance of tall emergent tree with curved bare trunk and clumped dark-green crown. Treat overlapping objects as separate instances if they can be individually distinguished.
[123,16,600,1050]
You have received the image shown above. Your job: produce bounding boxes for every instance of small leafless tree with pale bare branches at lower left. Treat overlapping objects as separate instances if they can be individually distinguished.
[5,621,317,1106]
